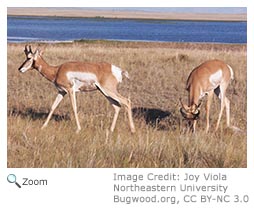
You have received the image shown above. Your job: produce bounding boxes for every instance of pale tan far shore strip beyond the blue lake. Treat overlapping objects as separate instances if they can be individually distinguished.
[7,7,247,22]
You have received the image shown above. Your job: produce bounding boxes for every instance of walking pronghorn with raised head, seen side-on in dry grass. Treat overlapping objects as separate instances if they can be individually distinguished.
[19,46,135,133]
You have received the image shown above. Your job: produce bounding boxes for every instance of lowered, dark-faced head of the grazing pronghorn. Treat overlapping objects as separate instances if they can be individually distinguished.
[180,98,201,120]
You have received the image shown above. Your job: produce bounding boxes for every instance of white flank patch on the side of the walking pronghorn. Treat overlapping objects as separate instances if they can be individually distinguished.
[67,72,97,91]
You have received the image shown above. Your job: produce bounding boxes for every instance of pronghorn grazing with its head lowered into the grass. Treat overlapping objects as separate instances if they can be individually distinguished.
[180,60,234,133]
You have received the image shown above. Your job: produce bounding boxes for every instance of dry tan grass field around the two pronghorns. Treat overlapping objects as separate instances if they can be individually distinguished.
[7,41,247,168]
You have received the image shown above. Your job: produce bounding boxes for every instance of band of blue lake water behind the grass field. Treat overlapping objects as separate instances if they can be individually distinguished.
[7,16,247,43]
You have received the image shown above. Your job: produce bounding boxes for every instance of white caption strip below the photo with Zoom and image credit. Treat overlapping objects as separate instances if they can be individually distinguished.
[3,169,253,210]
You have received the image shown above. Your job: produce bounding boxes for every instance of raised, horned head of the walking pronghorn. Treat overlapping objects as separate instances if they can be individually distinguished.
[19,45,40,73]
